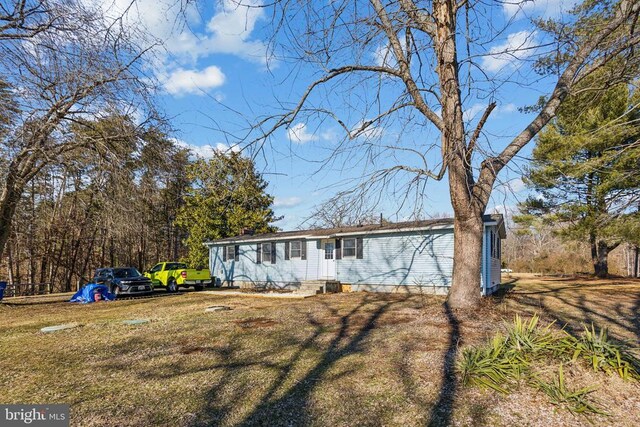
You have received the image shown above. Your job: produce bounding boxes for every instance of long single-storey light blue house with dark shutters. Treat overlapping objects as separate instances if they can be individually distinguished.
[205,215,505,295]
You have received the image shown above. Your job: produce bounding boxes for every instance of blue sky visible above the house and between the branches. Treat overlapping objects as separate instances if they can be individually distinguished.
[103,0,568,230]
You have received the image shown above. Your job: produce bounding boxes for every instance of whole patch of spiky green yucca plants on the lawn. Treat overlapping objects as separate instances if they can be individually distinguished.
[458,315,640,414]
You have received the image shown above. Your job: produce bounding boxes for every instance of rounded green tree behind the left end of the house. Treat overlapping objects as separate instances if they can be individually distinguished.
[176,152,280,267]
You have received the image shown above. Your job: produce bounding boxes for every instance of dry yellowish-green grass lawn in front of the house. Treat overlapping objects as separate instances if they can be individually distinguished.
[0,278,640,426]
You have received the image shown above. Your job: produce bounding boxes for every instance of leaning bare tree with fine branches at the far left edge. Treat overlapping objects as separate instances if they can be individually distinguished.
[0,0,159,257]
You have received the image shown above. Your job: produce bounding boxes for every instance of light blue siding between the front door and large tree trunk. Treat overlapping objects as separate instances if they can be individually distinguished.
[337,230,453,286]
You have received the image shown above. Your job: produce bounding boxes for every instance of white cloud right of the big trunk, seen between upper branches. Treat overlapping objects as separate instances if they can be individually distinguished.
[482,31,536,72]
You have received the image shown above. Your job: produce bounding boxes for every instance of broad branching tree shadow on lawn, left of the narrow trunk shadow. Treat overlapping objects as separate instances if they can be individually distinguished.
[191,296,409,426]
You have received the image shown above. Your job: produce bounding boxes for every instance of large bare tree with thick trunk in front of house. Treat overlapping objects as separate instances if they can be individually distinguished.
[239,0,640,308]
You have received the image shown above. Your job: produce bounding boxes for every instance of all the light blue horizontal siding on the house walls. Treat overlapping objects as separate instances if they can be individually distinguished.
[209,225,500,294]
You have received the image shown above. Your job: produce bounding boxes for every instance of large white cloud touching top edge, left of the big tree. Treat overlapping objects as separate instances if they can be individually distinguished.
[91,0,268,95]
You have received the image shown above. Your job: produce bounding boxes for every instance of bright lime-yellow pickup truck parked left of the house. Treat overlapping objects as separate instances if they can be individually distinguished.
[144,262,211,292]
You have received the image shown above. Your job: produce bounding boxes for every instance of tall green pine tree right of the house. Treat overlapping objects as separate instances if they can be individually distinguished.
[516,76,640,277]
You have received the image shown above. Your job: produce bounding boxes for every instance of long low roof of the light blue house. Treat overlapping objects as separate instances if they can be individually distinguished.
[205,214,505,246]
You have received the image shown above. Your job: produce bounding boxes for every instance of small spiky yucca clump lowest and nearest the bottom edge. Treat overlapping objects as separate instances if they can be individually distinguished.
[532,364,607,415]
